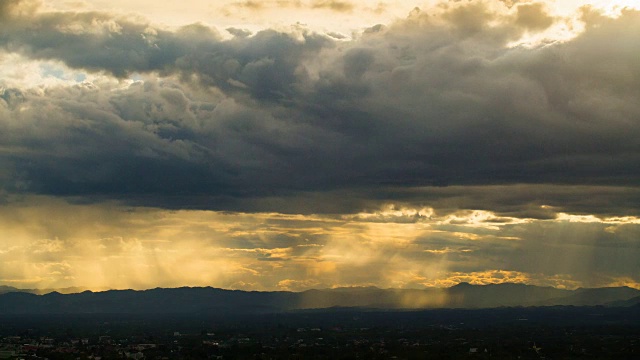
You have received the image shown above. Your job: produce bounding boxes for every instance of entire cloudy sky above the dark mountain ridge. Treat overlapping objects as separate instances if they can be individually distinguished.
[0,0,640,291]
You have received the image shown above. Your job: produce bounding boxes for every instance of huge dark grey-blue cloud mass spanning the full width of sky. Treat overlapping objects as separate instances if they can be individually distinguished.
[0,1,640,218]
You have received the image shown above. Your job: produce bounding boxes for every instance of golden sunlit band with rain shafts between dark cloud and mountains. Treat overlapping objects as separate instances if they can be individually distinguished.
[0,198,640,292]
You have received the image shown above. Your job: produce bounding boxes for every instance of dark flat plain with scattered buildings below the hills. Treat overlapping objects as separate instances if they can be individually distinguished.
[0,306,640,360]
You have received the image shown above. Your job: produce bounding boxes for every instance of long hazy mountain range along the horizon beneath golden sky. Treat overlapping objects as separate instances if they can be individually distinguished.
[0,283,640,314]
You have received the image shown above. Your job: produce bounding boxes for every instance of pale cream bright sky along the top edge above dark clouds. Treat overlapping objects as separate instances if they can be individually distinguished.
[38,0,640,34]
